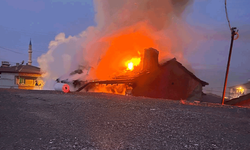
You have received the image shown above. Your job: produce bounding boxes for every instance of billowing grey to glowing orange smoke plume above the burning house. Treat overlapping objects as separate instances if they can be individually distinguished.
[37,0,193,86]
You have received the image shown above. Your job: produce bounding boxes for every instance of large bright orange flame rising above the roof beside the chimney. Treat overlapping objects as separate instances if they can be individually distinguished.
[95,27,156,80]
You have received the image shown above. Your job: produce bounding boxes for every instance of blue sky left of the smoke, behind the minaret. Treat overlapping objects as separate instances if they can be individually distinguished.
[0,0,95,65]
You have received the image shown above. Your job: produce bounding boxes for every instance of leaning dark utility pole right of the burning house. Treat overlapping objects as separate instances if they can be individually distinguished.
[221,27,239,105]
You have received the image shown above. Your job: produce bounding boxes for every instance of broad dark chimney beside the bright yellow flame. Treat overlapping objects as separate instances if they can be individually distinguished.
[143,48,159,71]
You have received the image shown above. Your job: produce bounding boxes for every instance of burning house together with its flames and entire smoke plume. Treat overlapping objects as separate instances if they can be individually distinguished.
[47,0,208,100]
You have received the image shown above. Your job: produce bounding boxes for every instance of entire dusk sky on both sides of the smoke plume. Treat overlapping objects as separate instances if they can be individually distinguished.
[0,0,250,95]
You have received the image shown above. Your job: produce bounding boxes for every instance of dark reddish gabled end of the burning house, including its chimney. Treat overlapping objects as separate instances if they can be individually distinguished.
[132,48,208,101]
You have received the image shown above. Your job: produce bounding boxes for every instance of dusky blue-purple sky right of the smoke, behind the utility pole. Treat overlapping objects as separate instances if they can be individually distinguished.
[186,0,250,95]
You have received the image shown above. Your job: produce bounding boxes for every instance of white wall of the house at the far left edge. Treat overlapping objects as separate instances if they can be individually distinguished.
[0,73,18,88]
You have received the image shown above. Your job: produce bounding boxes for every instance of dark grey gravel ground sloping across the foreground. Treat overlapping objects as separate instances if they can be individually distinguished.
[0,89,250,150]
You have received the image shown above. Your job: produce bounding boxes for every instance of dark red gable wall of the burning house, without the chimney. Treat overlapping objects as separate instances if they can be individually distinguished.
[132,61,201,100]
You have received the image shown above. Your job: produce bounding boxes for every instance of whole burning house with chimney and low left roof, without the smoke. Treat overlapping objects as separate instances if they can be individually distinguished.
[57,48,208,100]
